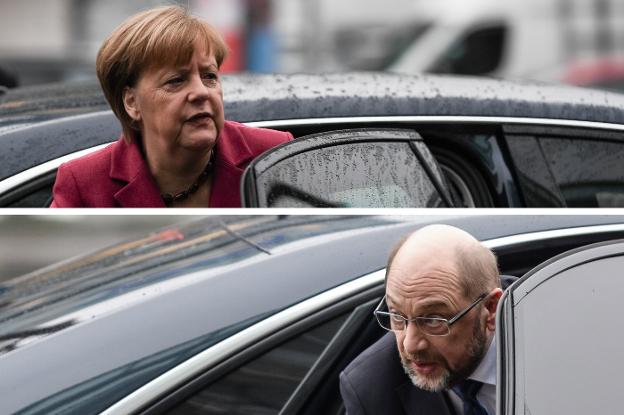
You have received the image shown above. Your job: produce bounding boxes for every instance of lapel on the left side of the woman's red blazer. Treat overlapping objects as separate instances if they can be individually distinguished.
[110,137,165,207]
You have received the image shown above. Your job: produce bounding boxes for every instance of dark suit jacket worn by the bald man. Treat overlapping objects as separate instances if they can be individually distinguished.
[340,275,517,415]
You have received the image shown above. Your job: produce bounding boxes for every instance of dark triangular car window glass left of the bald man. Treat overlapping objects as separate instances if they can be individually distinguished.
[168,314,347,415]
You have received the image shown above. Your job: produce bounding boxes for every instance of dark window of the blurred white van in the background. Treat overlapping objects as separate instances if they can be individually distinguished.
[430,25,507,75]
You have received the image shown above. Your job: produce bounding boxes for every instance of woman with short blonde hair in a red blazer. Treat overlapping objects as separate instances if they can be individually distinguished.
[52,6,293,207]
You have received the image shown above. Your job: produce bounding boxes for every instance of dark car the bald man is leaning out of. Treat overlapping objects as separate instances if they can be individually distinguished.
[0,215,624,415]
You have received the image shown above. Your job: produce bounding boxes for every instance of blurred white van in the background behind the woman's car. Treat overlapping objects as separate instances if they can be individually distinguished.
[335,0,624,80]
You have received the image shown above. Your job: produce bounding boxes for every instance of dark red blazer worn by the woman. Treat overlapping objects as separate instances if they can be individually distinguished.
[52,121,293,207]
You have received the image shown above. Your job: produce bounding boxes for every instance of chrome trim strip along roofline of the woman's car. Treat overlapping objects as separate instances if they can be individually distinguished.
[0,115,624,195]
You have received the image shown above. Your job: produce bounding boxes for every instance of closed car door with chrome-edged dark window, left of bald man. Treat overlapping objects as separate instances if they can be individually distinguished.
[97,270,384,415]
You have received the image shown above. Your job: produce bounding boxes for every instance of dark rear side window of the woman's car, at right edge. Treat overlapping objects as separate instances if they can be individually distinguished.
[540,138,624,207]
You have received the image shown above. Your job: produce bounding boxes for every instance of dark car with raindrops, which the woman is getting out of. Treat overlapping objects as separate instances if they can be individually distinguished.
[0,73,624,207]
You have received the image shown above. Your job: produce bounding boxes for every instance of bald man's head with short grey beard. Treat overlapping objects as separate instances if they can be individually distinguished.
[386,225,502,391]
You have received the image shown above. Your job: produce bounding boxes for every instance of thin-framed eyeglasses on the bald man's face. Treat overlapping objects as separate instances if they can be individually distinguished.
[373,293,487,336]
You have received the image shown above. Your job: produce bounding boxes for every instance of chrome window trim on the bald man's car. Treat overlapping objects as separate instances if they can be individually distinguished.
[102,223,624,415]
